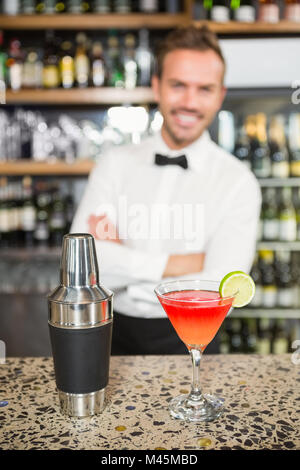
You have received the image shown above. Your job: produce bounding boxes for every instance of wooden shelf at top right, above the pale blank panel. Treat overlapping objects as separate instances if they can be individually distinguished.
[193,20,300,35]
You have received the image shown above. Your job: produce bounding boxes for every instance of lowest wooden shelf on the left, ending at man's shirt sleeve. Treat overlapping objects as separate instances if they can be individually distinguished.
[0,160,95,176]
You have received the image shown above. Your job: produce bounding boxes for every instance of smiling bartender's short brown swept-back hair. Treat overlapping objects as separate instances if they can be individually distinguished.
[155,25,225,77]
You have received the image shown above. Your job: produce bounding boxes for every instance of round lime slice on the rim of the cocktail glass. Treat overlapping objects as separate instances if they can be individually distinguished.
[219,271,255,307]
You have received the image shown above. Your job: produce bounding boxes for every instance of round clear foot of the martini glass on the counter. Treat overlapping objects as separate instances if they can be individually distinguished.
[169,394,224,423]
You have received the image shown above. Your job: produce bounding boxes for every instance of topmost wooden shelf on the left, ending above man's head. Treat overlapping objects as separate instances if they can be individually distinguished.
[0,13,189,30]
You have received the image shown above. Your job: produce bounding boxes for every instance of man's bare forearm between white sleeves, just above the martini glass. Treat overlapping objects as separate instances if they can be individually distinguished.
[163,253,205,277]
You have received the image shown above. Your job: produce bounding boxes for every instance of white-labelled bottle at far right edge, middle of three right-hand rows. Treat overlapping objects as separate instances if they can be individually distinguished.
[279,187,297,242]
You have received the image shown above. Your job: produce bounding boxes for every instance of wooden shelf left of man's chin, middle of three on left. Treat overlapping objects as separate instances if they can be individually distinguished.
[6,87,154,105]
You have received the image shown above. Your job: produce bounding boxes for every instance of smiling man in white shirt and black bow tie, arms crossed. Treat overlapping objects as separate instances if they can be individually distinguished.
[71,26,261,355]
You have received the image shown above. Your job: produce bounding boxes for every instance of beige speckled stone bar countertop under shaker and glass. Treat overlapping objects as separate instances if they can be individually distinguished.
[0,354,300,450]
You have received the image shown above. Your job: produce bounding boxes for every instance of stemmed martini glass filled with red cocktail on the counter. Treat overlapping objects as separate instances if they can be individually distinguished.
[155,280,234,423]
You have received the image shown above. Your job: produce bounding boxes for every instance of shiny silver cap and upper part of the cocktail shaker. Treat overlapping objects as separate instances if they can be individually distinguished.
[48,233,113,328]
